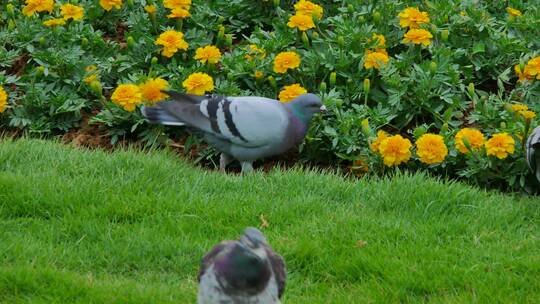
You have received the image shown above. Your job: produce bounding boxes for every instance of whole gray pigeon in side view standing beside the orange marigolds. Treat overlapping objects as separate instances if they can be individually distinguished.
[142,91,326,173]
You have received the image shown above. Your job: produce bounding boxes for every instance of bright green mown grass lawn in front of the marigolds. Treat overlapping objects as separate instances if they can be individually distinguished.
[0,140,540,303]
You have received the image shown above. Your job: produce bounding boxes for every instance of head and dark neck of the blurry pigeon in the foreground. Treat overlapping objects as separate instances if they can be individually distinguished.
[215,227,272,294]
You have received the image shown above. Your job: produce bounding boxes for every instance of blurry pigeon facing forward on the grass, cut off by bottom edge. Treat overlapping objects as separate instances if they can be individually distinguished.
[197,227,287,304]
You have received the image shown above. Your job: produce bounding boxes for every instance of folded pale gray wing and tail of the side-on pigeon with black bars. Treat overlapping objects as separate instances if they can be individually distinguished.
[143,91,289,147]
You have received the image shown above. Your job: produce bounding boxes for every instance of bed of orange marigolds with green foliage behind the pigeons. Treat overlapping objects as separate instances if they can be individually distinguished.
[0,0,540,190]
